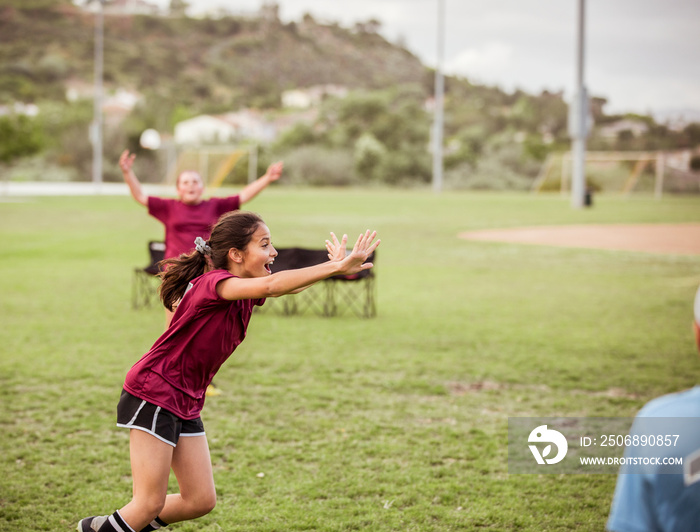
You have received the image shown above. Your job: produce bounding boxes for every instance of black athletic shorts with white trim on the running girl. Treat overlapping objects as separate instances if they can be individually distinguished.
[117,390,204,447]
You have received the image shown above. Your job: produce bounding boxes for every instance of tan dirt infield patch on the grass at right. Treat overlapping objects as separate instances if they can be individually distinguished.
[459,224,700,255]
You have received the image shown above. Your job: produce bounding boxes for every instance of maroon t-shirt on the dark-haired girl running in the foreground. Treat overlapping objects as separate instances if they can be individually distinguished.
[124,270,265,419]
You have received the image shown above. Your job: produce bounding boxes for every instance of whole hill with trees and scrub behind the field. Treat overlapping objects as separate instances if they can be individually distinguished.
[0,0,700,188]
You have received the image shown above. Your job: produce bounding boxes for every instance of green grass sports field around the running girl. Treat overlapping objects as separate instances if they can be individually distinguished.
[0,188,700,532]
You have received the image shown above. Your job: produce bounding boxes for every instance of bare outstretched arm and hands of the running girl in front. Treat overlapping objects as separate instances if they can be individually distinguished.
[216,231,381,300]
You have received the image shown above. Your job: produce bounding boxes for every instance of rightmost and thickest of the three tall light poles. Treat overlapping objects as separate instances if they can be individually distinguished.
[569,0,588,209]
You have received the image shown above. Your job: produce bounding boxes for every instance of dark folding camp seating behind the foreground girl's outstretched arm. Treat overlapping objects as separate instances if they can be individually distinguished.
[261,248,377,318]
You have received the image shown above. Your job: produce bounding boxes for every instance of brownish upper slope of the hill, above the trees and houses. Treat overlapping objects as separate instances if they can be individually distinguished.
[0,6,424,105]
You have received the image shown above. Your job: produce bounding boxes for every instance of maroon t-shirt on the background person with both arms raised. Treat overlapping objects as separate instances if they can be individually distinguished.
[148,196,241,259]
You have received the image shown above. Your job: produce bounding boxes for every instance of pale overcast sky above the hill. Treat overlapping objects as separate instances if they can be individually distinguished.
[157,0,700,120]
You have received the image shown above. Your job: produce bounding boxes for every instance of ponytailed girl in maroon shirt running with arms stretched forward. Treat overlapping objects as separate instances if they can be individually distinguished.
[78,211,380,532]
